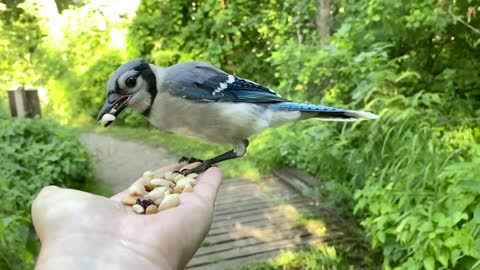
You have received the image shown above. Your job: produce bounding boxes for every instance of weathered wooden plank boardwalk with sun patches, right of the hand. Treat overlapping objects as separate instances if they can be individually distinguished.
[187,174,331,270]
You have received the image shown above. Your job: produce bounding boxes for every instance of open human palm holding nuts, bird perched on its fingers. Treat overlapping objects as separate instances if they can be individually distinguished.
[32,164,221,270]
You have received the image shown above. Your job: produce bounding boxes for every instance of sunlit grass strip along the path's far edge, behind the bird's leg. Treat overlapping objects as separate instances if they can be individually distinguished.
[79,125,260,180]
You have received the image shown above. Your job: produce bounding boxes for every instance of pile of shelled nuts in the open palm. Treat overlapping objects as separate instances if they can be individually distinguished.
[122,171,198,215]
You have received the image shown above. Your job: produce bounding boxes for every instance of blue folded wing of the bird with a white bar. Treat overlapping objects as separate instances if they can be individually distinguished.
[162,62,287,103]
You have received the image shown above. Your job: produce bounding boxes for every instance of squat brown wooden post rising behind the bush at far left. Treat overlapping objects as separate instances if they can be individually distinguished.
[8,86,41,117]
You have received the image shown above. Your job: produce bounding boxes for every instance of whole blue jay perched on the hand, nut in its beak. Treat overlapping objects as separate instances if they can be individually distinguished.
[97,59,379,175]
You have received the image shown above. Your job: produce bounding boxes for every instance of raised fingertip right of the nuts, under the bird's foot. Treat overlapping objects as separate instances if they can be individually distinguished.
[190,167,222,205]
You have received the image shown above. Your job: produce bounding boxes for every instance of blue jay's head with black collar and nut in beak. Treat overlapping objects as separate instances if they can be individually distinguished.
[97,60,157,127]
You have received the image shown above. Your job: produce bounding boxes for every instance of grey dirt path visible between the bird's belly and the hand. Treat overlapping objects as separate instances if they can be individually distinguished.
[80,133,177,192]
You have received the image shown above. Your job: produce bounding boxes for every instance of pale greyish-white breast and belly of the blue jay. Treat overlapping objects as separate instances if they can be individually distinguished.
[149,92,272,143]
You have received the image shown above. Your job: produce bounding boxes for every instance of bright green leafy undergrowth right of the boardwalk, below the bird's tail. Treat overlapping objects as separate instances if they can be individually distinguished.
[254,90,480,269]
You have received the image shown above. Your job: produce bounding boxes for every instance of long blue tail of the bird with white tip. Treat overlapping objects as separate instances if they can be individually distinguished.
[270,102,379,121]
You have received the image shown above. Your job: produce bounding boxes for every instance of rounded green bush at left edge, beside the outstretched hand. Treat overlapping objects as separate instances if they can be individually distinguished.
[0,119,91,269]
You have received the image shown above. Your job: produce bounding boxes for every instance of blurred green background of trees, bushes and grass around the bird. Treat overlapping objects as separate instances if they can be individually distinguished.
[0,0,480,269]
